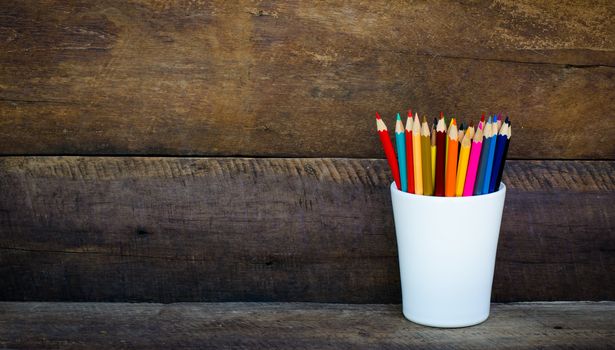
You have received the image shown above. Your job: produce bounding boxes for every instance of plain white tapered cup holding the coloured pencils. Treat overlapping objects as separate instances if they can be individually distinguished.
[391,183,506,327]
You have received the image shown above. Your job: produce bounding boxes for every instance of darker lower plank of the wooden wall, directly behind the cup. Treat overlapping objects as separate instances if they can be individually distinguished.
[0,157,615,303]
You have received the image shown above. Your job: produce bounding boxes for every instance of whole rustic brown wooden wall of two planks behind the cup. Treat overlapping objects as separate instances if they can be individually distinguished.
[0,0,615,303]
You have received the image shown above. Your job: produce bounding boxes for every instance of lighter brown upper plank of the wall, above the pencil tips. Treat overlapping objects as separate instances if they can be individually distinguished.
[0,0,615,159]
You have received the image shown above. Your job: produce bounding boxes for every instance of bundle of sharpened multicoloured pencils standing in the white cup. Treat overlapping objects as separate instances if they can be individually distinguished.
[376,111,511,197]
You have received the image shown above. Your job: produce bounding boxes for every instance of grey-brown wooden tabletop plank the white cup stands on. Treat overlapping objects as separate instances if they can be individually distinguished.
[0,302,615,349]
